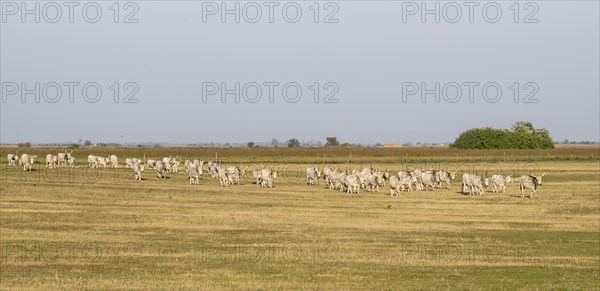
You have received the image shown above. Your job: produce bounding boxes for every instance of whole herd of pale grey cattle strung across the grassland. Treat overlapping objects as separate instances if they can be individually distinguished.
[7,151,545,198]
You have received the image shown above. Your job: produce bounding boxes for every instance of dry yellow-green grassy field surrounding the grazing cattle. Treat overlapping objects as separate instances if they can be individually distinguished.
[0,148,600,290]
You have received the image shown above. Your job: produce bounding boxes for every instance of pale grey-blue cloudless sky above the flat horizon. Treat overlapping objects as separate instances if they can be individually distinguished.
[0,1,600,144]
